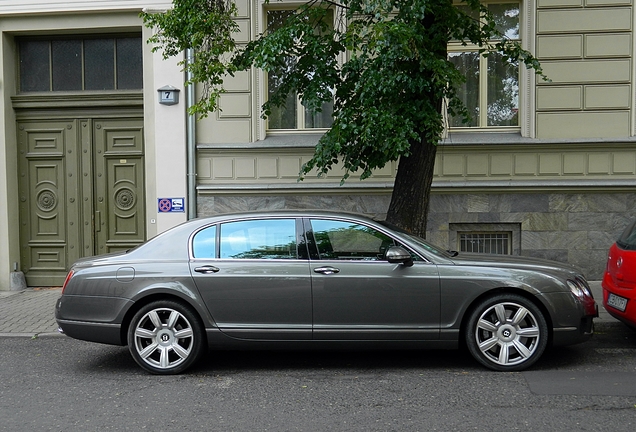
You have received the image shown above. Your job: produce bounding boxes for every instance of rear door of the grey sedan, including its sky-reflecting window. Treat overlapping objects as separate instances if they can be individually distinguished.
[190,218,312,340]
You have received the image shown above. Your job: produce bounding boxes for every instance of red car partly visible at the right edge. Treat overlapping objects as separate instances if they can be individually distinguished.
[602,220,636,329]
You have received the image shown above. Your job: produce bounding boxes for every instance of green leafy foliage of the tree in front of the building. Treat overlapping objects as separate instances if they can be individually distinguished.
[143,0,542,234]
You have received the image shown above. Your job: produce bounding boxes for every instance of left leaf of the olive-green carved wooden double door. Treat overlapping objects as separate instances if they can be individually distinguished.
[18,120,82,286]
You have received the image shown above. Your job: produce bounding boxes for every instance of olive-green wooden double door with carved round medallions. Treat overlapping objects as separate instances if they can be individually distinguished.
[17,118,146,286]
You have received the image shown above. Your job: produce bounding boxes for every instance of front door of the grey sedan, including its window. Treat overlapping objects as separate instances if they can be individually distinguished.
[305,218,440,340]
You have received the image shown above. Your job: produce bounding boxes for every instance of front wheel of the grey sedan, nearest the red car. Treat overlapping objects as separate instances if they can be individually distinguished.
[465,294,548,371]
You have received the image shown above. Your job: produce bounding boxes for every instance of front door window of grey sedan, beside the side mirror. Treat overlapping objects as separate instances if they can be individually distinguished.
[311,219,395,261]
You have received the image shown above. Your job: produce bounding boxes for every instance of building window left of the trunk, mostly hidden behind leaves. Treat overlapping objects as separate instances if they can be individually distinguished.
[267,9,333,130]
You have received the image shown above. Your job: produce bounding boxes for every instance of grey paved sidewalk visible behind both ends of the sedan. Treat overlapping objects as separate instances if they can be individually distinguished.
[0,281,618,338]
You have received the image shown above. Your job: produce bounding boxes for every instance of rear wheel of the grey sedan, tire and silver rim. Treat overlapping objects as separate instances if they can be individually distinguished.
[128,300,206,375]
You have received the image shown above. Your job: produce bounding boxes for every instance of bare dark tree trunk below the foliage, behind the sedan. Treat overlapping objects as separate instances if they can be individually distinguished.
[386,140,437,237]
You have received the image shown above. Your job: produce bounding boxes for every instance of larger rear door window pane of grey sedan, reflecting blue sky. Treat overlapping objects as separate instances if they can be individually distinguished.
[219,219,298,259]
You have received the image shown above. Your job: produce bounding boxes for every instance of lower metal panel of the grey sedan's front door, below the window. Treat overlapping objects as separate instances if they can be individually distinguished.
[311,260,440,340]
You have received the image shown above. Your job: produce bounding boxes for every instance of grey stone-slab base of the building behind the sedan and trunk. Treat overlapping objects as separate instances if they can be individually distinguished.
[198,191,636,280]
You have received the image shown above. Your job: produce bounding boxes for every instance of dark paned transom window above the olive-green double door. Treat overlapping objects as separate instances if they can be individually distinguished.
[18,36,143,92]
